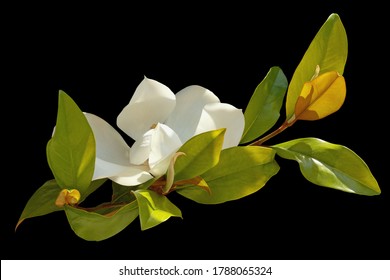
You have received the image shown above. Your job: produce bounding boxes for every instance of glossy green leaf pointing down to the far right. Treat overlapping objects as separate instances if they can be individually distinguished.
[272,138,381,195]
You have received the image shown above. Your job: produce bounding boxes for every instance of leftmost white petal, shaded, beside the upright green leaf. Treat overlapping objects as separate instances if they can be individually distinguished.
[85,113,130,179]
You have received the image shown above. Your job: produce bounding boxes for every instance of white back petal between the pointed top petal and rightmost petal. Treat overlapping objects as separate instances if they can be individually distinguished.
[165,85,219,143]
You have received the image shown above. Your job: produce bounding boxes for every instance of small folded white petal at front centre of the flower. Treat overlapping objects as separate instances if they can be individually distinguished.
[149,124,182,176]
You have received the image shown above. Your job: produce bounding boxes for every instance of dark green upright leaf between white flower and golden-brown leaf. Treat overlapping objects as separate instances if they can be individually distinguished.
[241,67,288,143]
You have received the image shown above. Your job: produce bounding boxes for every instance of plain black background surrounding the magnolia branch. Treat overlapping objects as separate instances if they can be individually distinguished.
[1,1,390,259]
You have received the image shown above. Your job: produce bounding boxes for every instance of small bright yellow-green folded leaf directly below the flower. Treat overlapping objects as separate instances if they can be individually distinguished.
[133,190,182,230]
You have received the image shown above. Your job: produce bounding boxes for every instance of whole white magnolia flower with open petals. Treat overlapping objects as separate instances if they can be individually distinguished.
[85,77,244,186]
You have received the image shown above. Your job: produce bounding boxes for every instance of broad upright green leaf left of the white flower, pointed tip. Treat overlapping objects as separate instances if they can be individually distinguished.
[46,91,95,196]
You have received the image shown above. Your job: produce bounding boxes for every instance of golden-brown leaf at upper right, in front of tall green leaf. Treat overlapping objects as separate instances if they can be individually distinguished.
[294,71,346,120]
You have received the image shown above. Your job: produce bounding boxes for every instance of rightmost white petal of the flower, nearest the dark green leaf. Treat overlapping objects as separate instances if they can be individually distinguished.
[196,103,245,149]
